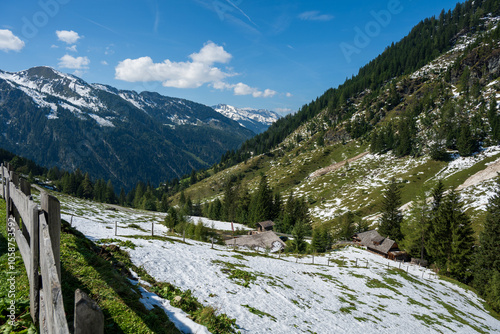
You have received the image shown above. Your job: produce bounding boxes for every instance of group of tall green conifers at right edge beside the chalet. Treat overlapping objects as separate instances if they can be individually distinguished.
[378,177,500,311]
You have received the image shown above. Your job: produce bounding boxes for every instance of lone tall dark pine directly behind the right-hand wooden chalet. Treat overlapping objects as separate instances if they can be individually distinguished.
[378,178,403,241]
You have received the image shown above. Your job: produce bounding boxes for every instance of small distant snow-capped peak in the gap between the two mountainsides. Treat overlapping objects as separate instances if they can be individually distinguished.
[212,104,280,134]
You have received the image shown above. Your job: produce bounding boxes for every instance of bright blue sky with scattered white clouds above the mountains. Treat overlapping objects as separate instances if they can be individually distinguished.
[0,0,456,113]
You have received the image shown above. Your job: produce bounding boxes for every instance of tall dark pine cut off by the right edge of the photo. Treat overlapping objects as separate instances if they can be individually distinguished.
[473,177,500,296]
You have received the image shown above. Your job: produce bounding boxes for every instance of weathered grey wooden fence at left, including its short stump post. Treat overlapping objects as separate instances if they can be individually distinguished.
[0,164,104,334]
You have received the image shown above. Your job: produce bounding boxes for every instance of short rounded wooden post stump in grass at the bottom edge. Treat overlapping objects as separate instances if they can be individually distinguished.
[75,289,104,334]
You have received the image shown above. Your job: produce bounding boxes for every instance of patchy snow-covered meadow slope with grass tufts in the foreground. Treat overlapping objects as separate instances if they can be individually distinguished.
[48,192,500,333]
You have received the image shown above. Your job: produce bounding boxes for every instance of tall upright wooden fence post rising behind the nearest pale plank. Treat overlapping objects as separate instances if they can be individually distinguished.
[42,192,61,279]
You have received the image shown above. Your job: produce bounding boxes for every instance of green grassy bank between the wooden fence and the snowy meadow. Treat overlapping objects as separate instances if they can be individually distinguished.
[61,222,179,333]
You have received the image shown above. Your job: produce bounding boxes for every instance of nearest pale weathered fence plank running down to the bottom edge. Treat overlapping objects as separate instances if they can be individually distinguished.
[39,213,69,334]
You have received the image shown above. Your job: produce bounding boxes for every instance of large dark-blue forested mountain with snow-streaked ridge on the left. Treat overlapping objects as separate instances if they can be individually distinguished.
[0,67,254,188]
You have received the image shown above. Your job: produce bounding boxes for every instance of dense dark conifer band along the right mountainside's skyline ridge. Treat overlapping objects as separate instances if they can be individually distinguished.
[217,0,500,166]
